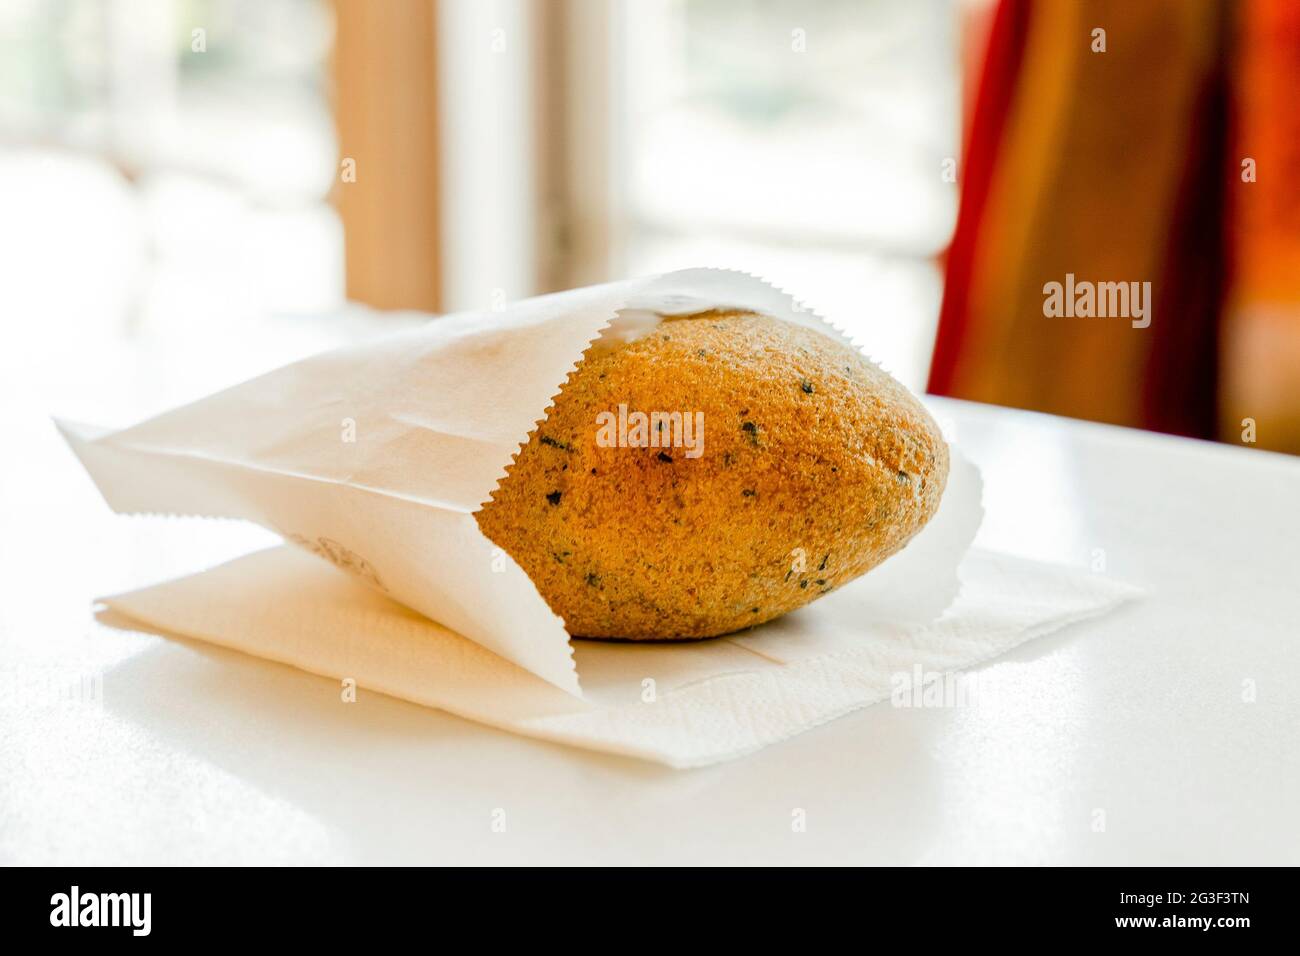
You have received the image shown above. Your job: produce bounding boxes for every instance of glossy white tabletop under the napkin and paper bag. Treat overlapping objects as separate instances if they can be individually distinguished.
[0,317,1300,864]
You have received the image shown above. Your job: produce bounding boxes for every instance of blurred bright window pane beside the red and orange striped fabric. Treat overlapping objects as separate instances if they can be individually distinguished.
[603,0,959,388]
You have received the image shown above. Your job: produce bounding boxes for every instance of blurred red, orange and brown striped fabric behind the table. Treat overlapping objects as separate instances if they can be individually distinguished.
[930,0,1300,451]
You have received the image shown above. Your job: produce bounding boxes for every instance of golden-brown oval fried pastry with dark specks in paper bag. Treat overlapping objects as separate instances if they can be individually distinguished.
[477,312,948,640]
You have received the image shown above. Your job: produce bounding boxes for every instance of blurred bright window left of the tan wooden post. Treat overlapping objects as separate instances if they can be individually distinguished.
[0,0,342,328]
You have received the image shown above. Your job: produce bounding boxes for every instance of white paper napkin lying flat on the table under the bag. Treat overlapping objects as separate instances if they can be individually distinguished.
[98,548,1138,767]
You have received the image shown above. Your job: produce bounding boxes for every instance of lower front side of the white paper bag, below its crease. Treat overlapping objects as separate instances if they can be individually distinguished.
[64,408,581,695]
